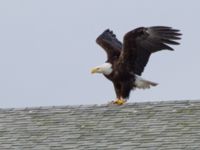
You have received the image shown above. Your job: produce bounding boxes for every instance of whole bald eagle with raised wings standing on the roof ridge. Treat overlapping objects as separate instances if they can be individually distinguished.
[91,26,181,105]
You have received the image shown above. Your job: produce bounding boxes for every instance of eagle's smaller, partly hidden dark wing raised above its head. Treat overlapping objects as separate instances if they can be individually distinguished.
[96,29,122,60]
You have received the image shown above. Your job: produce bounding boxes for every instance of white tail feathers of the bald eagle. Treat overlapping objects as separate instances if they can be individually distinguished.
[135,75,158,89]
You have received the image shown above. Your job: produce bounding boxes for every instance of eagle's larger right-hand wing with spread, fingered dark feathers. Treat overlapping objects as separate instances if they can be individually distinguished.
[120,26,181,75]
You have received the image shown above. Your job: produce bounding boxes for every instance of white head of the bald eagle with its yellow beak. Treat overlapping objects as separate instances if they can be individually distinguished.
[91,63,113,75]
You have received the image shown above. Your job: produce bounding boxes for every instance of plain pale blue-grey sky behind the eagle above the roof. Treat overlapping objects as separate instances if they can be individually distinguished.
[0,0,200,107]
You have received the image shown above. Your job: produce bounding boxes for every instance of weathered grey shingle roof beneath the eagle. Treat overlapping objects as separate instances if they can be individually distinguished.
[0,101,200,150]
